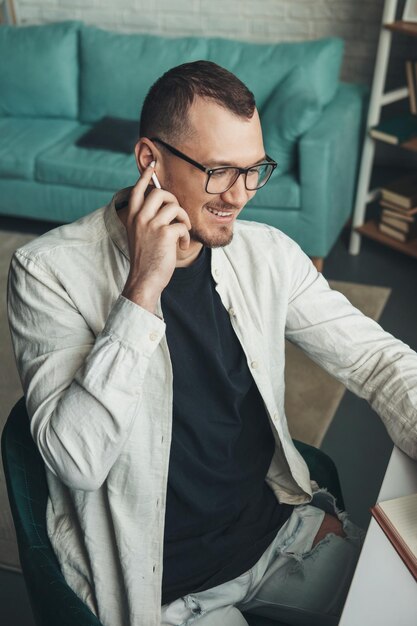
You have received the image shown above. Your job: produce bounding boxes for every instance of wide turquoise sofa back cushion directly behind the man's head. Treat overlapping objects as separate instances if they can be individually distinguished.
[80,26,343,122]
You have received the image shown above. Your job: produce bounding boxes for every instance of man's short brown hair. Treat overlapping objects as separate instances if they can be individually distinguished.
[140,61,255,141]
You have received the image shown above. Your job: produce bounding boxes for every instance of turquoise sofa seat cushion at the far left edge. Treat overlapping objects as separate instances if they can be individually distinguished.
[0,117,78,180]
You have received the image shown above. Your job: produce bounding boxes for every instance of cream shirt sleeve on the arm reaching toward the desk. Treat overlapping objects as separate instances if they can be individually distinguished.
[286,234,417,458]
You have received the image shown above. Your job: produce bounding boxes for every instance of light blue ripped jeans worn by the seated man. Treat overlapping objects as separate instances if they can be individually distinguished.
[161,489,365,626]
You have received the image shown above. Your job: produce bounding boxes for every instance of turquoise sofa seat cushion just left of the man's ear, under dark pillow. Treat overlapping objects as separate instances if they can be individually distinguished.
[35,124,138,192]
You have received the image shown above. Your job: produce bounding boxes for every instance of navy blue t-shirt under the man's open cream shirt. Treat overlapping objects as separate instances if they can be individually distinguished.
[162,248,293,604]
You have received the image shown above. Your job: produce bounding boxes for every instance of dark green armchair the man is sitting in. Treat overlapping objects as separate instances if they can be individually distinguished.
[1,398,344,626]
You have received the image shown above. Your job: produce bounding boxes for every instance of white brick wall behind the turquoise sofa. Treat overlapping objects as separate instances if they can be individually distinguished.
[15,0,416,86]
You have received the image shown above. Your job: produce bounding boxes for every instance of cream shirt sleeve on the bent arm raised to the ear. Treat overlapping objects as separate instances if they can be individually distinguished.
[8,251,165,490]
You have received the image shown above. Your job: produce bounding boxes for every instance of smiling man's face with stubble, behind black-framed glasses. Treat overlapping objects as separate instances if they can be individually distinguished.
[158,98,265,248]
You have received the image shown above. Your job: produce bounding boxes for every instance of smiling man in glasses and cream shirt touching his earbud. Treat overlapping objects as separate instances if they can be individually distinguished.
[5,61,417,626]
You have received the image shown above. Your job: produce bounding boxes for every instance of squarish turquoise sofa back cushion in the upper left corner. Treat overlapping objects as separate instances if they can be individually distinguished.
[0,22,79,119]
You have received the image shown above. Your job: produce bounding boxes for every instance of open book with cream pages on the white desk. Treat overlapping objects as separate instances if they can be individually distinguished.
[371,493,417,580]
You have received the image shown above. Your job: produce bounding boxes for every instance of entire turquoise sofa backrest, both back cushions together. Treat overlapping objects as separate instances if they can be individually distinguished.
[0,22,343,149]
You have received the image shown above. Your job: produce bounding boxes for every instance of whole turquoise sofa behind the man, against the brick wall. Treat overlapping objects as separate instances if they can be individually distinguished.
[0,22,366,257]
